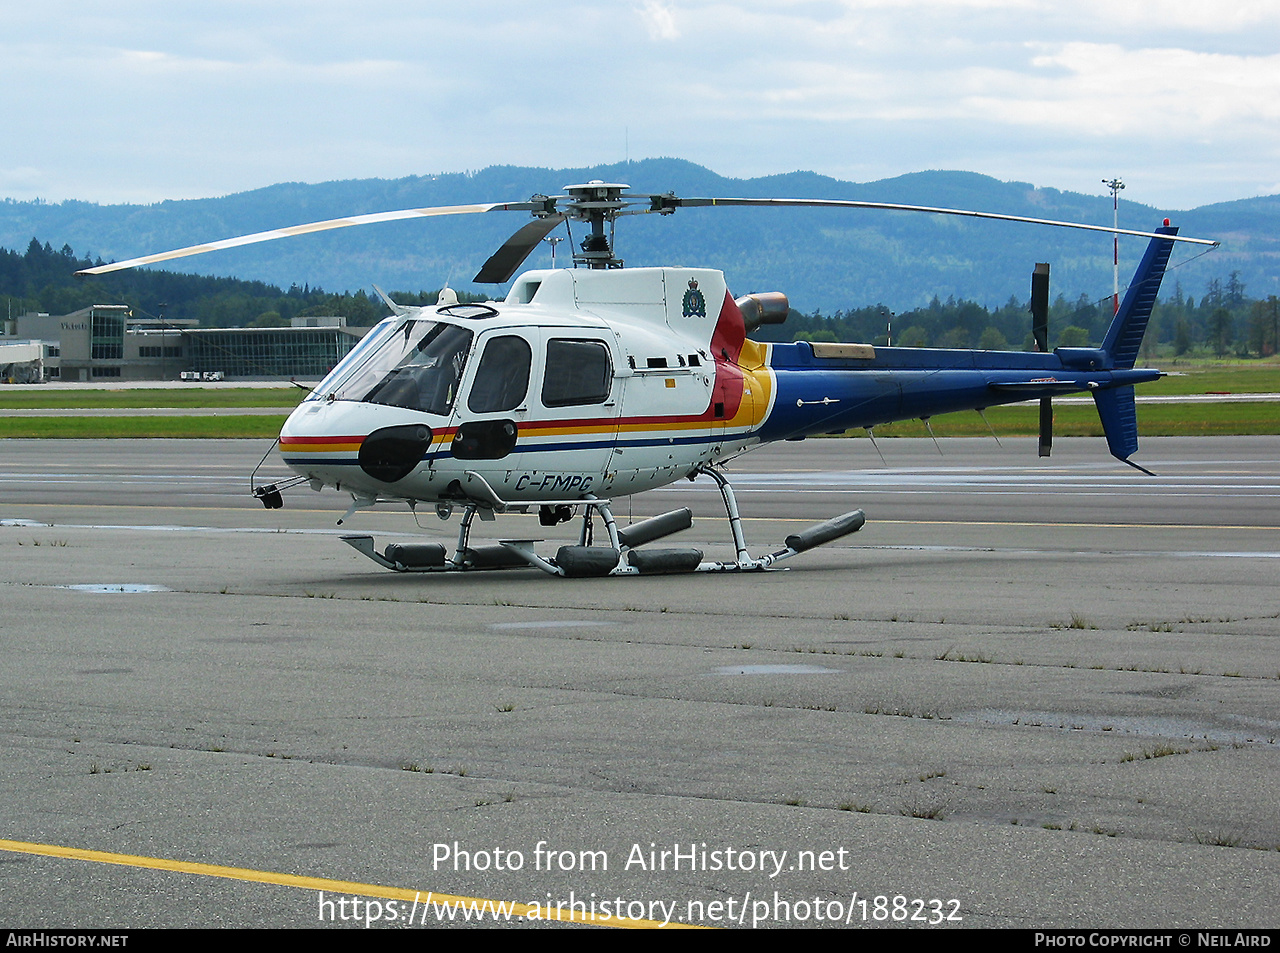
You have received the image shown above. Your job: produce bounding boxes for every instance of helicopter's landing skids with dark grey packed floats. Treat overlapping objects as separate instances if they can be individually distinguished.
[340,467,867,578]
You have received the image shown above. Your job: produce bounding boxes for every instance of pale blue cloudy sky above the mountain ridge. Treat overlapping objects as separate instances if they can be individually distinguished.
[0,0,1280,209]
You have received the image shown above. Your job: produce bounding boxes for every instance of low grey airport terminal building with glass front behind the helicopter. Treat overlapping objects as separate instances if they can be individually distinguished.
[0,304,369,382]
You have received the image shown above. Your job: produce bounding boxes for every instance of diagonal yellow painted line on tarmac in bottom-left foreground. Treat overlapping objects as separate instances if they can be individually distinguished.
[0,839,701,930]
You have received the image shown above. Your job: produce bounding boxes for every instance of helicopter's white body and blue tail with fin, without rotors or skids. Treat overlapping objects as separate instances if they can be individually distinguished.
[280,218,1175,524]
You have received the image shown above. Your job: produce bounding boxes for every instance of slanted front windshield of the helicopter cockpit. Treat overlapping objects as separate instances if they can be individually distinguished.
[333,320,471,416]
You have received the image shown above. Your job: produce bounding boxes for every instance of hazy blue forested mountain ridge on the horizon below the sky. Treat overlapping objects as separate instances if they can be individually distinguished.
[0,159,1280,313]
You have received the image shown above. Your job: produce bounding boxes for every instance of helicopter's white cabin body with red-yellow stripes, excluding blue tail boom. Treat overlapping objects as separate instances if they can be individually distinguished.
[280,267,774,504]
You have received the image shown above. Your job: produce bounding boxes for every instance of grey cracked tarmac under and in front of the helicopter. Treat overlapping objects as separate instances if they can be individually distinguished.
[0,437,1280,929]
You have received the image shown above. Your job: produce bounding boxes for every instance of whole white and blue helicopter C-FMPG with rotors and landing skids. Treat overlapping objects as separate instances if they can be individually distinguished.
[78,180,1217,577]
